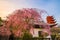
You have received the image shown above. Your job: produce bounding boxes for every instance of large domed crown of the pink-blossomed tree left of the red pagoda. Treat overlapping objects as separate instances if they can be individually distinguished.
[0,8,50,37]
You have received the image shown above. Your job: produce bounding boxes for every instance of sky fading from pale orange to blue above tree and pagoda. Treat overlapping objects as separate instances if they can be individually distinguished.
[0,0,60,24]
